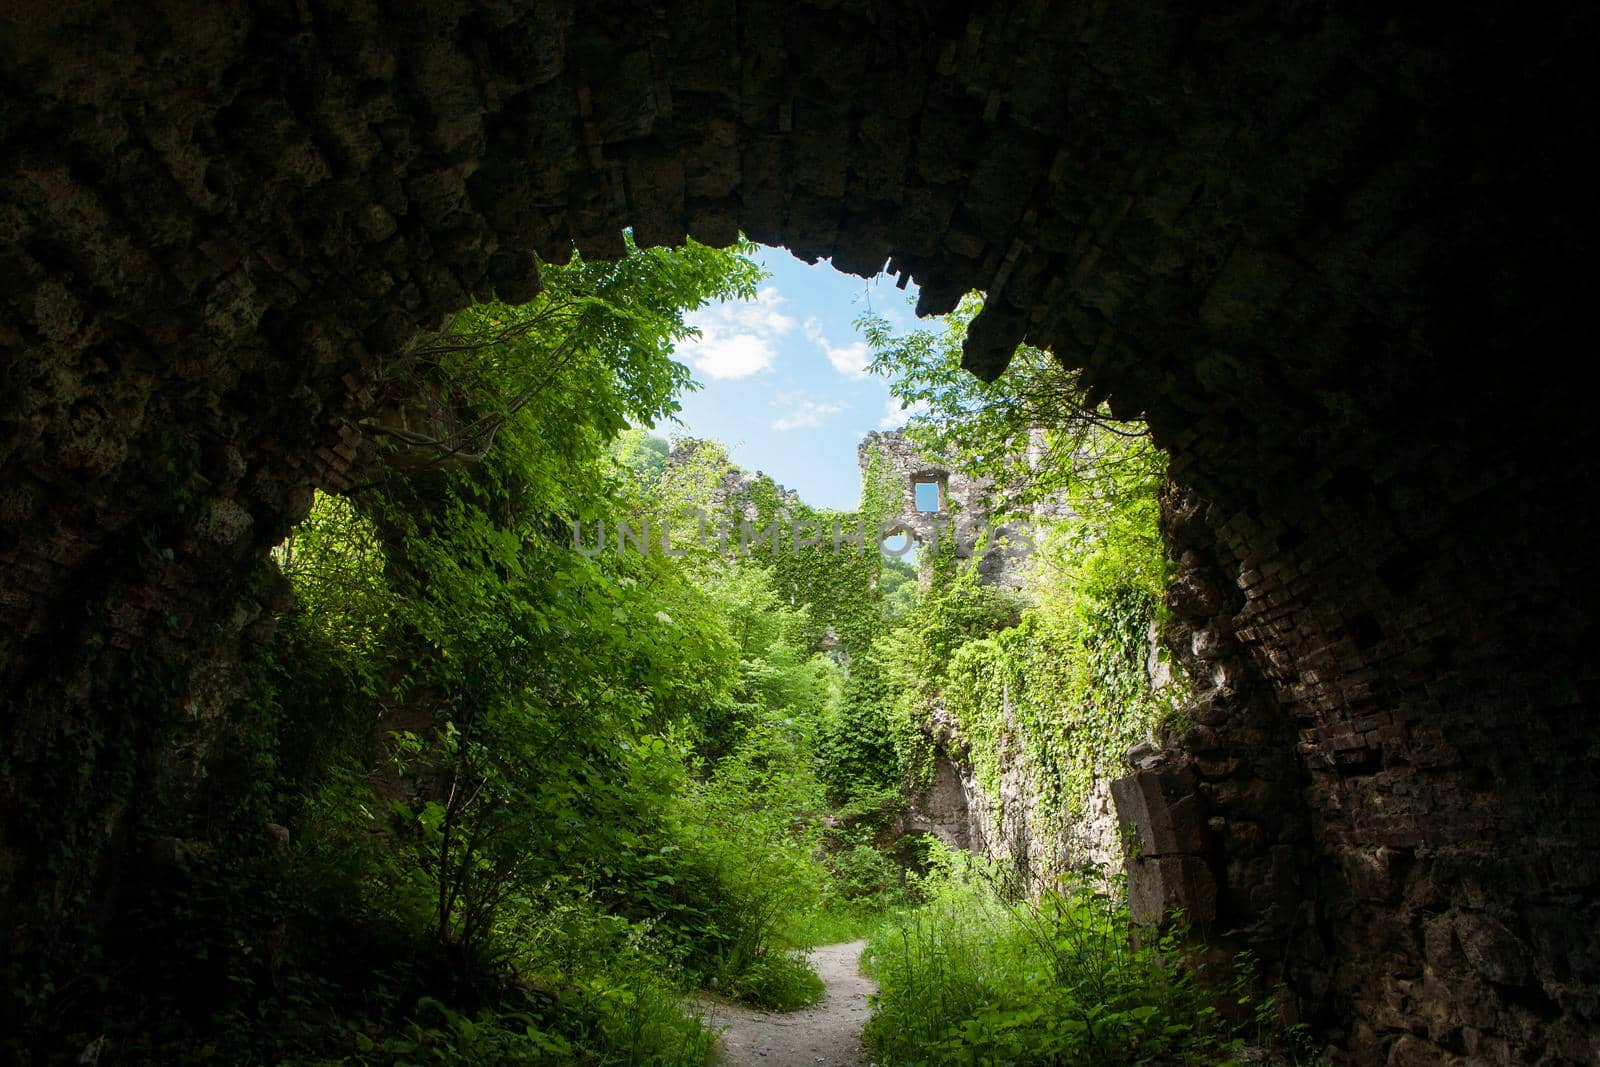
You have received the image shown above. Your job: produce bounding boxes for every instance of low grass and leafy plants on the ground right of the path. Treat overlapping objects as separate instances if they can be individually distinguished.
[867,854,1270,1067]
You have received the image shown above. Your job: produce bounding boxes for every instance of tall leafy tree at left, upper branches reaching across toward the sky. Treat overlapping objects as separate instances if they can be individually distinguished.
[357,245,768,965]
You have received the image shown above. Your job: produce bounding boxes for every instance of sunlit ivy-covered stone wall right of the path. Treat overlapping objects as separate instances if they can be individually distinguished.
[875,425,1184,881]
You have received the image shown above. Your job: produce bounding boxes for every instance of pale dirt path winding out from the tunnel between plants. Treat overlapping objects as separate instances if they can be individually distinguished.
[701,941,875,1067]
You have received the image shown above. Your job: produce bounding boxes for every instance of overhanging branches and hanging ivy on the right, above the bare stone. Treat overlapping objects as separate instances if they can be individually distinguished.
[862,289,1179,867]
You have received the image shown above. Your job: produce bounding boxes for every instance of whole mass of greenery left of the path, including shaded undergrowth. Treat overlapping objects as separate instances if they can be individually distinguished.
[64,245,837,1064]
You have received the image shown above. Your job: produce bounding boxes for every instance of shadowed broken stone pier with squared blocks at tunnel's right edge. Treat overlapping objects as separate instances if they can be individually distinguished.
[1112,490,1330,991]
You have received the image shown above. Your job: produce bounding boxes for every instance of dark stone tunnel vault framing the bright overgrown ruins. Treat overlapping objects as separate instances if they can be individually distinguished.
[0,0,1600,1064]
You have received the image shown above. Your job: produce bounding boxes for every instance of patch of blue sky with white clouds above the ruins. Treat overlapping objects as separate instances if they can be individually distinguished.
[656,248,917,509]
